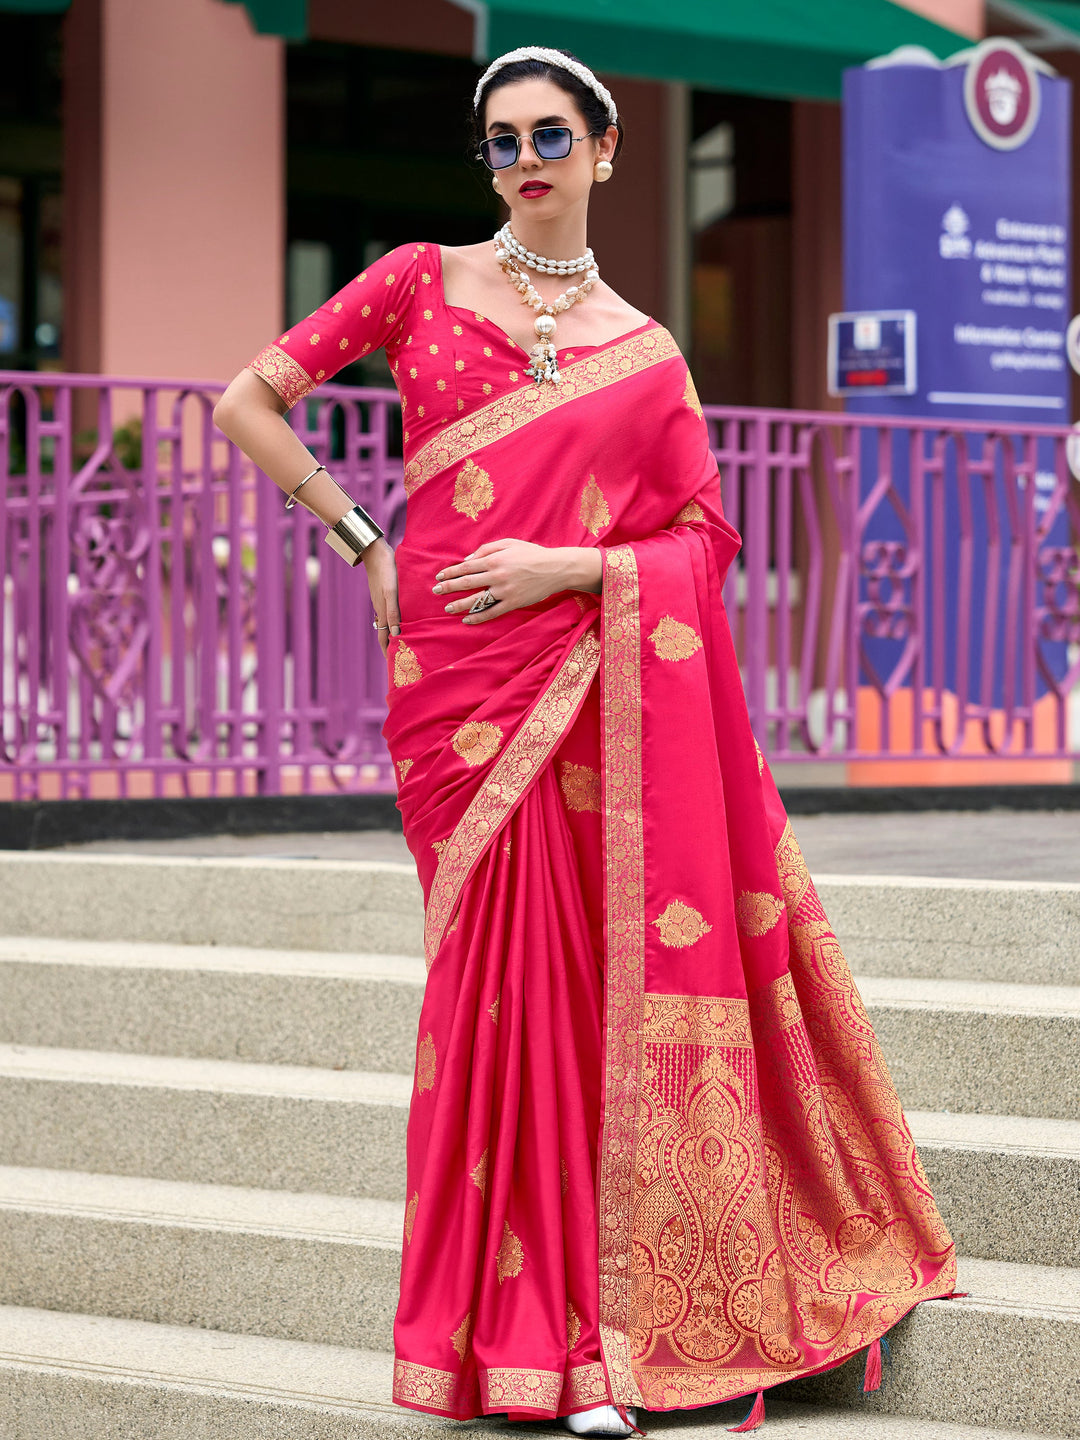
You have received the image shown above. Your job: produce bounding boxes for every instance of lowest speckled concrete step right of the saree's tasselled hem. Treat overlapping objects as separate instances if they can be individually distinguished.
[785,1259,1080,1437]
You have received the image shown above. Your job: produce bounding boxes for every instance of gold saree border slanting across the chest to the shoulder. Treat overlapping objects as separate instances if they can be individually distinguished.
[405,325,681,495]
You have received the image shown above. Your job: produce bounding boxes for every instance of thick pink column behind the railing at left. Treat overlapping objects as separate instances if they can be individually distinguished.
[65,0,285,379]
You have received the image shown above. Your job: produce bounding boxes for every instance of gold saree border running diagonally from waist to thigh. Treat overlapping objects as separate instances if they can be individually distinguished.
[423,629,600,969]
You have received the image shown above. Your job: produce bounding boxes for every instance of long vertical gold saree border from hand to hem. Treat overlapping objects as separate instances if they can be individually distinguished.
[599,546,645,1405]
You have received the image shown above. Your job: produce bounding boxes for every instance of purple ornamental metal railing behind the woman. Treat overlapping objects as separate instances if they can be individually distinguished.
[0,372,1080,799]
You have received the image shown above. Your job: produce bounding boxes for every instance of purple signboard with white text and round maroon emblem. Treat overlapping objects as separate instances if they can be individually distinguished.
[844,39,1071,717]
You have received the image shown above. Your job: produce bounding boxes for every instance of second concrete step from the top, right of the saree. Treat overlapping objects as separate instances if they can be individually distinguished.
[855,975,1080,1120]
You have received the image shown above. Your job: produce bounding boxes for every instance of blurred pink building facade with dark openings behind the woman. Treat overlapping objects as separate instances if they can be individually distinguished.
[0,0,1008,408]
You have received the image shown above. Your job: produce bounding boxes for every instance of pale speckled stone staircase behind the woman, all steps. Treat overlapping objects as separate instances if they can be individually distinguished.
[0,852,1080,1440]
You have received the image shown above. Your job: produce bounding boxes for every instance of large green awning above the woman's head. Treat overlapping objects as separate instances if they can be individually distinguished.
[454,0,971,99]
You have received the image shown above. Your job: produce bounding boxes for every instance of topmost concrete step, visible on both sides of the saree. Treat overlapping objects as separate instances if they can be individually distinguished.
[0,851,1080,985]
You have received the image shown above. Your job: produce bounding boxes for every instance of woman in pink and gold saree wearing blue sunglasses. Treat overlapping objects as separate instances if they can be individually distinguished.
[216,48,955,1434]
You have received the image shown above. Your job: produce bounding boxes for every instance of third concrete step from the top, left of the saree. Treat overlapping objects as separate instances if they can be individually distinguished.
[0,1045,412,1200]
